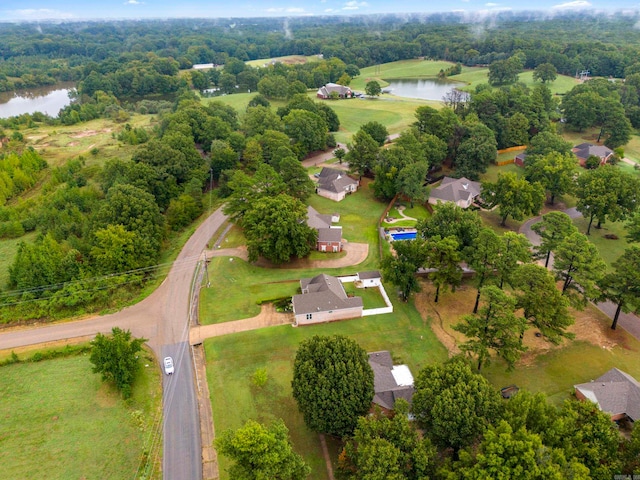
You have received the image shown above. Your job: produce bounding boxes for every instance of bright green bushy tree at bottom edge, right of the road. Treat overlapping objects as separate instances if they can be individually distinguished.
[215,420,311,480]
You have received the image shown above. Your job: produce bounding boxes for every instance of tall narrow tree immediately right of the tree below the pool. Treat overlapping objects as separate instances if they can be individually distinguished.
[426,235,462,303]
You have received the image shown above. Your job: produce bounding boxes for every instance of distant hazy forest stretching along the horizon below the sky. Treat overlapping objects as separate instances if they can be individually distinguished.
[0,13,640,92]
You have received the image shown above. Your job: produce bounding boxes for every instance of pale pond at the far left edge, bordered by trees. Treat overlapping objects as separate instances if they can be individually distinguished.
[0,84,73,118]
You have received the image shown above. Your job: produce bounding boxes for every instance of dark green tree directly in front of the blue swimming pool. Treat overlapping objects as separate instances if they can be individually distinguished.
[382,238,427,302]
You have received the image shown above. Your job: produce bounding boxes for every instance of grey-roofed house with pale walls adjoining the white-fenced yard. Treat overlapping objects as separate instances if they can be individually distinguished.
[292,273,363,325]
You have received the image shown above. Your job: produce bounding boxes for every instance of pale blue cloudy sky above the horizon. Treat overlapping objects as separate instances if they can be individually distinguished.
[0,0,640,21]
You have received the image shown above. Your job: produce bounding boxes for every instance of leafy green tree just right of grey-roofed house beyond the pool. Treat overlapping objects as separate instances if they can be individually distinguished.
[482,172,544,226]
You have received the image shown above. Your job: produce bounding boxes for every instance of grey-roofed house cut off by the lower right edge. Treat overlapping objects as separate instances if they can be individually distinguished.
[574,368,640,422]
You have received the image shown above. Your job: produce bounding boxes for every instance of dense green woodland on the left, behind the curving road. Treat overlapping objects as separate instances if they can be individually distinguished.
[0,90,339,322]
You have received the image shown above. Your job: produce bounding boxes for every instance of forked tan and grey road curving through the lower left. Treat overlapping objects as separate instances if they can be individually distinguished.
[0,209,226,480]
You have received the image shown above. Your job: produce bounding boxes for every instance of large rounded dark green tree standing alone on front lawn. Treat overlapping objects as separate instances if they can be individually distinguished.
[291,335,374,437]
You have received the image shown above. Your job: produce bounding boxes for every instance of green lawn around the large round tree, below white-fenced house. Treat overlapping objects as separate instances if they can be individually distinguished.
[204,296,447,480]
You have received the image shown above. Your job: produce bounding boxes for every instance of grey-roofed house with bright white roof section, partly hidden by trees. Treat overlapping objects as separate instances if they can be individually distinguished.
[368,350,413,410]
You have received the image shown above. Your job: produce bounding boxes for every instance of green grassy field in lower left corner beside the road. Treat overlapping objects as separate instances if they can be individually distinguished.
[0,354,162,480]
